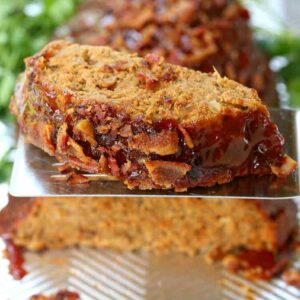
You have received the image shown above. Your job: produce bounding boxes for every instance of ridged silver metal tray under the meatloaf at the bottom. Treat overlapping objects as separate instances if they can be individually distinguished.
[0,242,300,300]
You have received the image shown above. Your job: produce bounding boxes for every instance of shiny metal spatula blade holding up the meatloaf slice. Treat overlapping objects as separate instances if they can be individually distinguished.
[10,109,300,199]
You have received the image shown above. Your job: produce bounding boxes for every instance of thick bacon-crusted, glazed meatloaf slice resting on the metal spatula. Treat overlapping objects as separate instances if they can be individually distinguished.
[11,41,296,191]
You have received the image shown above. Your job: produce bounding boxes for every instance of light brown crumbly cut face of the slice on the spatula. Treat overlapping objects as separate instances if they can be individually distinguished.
[26,41,268,124]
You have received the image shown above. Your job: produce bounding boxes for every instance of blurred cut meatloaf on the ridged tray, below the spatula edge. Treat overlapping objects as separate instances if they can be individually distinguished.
[0,197,297,258]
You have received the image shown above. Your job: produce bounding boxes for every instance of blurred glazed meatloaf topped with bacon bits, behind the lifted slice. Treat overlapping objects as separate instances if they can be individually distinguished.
[56,0,278,106]
